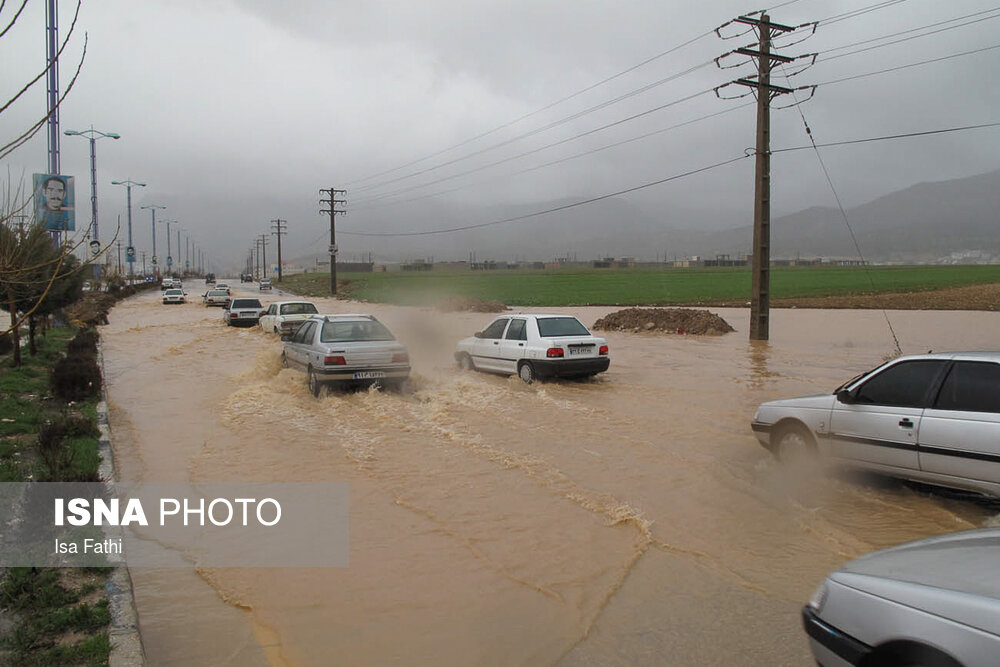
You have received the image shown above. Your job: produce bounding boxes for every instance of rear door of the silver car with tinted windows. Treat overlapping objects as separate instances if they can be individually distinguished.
[919,361,1000,483]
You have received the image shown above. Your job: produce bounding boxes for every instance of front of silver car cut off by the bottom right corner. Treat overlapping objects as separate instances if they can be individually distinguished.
[802,528,1000,667]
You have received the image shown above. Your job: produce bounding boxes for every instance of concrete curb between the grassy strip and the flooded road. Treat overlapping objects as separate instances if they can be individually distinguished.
[97,343,146,667]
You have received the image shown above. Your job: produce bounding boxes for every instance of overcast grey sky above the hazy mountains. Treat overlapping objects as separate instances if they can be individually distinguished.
[0,0,1000,268]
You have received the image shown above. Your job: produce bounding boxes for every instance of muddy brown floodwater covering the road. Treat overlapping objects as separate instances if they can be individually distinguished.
[102,289,1000,667]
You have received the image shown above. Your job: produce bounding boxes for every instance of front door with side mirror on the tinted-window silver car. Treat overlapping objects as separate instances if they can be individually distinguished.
[826,359,947,470]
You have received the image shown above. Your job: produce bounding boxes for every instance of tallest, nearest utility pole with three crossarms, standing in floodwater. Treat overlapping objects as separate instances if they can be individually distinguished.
[717,13,795,340]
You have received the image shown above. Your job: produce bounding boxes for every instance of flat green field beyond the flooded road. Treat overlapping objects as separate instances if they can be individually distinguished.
[282,266,1000,306]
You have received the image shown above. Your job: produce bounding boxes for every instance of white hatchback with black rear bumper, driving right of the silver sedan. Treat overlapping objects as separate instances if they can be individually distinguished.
[455,314,611,384]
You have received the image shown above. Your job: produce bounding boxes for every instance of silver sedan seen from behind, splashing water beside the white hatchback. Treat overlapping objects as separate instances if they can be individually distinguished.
[281,315,410,396]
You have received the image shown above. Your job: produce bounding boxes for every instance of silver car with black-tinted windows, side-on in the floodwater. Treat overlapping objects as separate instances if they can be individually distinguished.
[751,352,1000,498]
